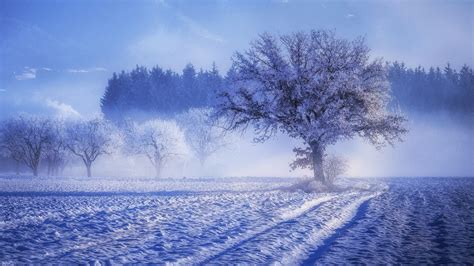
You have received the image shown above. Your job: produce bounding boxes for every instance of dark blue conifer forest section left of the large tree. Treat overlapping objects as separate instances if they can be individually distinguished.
[101,64,223,121]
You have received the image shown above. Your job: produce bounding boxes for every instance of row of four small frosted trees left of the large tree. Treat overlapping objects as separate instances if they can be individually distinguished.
[0,109,225,177]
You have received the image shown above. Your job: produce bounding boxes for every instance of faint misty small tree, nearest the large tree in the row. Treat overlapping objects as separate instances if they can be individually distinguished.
[177,108,226,166]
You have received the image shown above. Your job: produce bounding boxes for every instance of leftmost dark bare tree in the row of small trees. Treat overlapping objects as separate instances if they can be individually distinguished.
[0,116,52,176]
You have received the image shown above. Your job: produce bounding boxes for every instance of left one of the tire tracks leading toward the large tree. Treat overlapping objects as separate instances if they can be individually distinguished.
[176,193,344,265]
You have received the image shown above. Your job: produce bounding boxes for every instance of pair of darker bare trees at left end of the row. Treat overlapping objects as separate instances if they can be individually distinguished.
[0,116,114,176]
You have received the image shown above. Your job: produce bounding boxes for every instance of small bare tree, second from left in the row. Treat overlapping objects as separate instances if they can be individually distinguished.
[66,119,119,177]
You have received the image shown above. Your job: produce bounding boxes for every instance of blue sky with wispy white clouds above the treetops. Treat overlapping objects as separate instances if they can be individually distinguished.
[0,0,474,117]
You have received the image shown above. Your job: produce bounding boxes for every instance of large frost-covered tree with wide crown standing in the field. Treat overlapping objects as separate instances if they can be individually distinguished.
[218,31,407,183]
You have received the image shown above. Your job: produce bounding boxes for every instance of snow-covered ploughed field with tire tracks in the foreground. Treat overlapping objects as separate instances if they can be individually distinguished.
[0,177,474,265]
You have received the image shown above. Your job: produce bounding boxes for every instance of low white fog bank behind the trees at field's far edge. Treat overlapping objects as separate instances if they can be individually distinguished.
[25,112,468,178]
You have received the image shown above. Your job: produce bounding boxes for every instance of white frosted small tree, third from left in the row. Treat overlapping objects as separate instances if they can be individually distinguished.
[125,119,187,178]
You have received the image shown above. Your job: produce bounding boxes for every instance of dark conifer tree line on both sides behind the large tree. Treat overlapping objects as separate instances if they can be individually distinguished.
[101,62,474,122]
